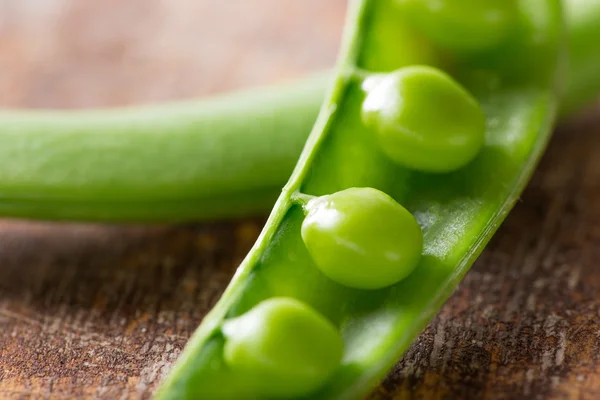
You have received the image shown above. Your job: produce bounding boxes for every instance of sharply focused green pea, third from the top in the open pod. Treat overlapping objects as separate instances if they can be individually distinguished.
[301,188,423,289]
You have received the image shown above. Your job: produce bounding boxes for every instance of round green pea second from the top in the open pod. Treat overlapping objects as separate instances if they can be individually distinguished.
[362,66,485,172]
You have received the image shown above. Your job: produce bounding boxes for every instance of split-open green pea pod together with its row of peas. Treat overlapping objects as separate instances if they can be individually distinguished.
[158,0,563,399]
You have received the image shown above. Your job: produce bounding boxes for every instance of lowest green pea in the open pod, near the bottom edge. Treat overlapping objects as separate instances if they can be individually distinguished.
[222,297,343,398]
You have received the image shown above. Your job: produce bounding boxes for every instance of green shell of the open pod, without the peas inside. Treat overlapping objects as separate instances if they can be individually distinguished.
[157,0,563,400]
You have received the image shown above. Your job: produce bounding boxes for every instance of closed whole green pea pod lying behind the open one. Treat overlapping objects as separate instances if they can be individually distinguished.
[0,0,600,222]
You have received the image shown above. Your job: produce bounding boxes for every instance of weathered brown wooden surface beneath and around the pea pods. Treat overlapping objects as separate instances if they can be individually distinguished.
[0,0,600,400]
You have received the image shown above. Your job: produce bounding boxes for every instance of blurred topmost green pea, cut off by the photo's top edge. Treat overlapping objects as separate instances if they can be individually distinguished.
[396,0,518,51]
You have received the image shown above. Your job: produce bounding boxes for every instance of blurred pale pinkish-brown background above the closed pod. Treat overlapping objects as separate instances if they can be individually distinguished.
[0,0,346,108]
